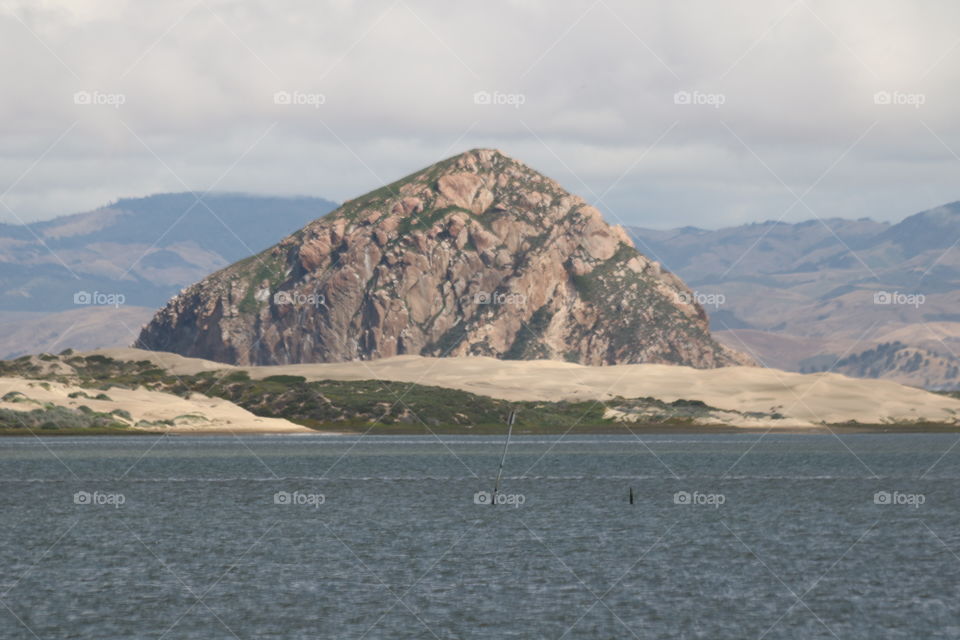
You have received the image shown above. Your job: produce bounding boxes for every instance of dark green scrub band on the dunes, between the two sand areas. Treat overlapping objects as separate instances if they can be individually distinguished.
[0,354,744,433]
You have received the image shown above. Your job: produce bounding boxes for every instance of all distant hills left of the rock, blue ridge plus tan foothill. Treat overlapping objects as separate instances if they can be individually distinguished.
[0,193,336,357]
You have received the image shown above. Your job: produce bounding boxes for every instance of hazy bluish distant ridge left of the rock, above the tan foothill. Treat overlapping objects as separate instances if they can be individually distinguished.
[0,193,336,311]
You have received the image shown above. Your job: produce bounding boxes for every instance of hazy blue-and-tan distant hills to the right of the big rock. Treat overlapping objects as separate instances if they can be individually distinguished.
[630,203,960,389]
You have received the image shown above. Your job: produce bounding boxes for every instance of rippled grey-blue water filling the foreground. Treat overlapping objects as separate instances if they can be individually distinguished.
[0,434,960,640]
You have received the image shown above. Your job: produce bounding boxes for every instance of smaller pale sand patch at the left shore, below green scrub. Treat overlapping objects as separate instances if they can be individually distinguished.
[0,378,316,434]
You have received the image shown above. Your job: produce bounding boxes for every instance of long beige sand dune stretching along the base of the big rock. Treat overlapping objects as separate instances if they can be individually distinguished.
[96,349,960,427]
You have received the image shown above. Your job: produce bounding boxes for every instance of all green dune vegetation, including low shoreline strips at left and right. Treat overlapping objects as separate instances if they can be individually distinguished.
[0,351,960,435]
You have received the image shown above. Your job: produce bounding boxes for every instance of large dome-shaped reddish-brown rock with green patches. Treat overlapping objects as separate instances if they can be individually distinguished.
[136,149,752,368]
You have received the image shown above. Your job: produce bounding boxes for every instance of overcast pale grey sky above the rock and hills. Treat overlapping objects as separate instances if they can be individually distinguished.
[0,0,960,228]
